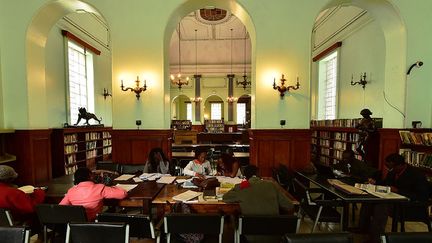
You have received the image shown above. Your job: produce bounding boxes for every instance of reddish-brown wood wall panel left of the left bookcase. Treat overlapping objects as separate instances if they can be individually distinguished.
[7,129,51,185]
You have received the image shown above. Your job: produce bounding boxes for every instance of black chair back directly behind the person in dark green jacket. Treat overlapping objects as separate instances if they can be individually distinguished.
[234,215,300,243]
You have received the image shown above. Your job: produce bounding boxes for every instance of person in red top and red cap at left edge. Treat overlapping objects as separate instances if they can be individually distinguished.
[0,165,45,230]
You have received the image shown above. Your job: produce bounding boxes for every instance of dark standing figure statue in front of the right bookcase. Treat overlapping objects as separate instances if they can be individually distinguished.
[356,109,376,160]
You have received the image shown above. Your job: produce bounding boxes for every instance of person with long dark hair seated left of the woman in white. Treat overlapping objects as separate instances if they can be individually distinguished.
[144,148,174,175]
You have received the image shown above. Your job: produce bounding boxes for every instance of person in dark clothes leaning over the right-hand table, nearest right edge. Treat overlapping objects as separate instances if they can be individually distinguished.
[359,153,429,242]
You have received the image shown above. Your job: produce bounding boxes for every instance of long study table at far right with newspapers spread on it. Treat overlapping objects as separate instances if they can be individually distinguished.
[297,172,409,232]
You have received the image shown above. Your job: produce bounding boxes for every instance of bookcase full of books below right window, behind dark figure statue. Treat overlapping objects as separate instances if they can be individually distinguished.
[311,118,382,166]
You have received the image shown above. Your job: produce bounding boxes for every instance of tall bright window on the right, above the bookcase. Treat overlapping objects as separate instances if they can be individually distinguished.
[317,50,340,120]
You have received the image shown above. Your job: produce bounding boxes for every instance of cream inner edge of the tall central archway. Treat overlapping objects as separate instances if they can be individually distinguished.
[163,0,256,127]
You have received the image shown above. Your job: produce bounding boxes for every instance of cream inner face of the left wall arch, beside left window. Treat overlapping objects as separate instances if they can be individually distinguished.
[26,0,109,128]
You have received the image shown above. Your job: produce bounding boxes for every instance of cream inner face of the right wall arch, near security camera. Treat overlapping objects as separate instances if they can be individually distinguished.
[311,0,407,128]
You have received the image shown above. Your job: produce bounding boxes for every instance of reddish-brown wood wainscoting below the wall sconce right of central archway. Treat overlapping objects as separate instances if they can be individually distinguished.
[249,129,311,176]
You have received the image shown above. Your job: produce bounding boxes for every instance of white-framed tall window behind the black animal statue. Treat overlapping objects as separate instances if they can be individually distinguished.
[65,38,96,124]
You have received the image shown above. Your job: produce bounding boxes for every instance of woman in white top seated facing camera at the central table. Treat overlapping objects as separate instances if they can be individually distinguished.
[183,149,213,177]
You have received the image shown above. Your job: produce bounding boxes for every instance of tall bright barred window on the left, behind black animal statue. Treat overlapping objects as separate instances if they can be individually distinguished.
[67,40,95,124]
